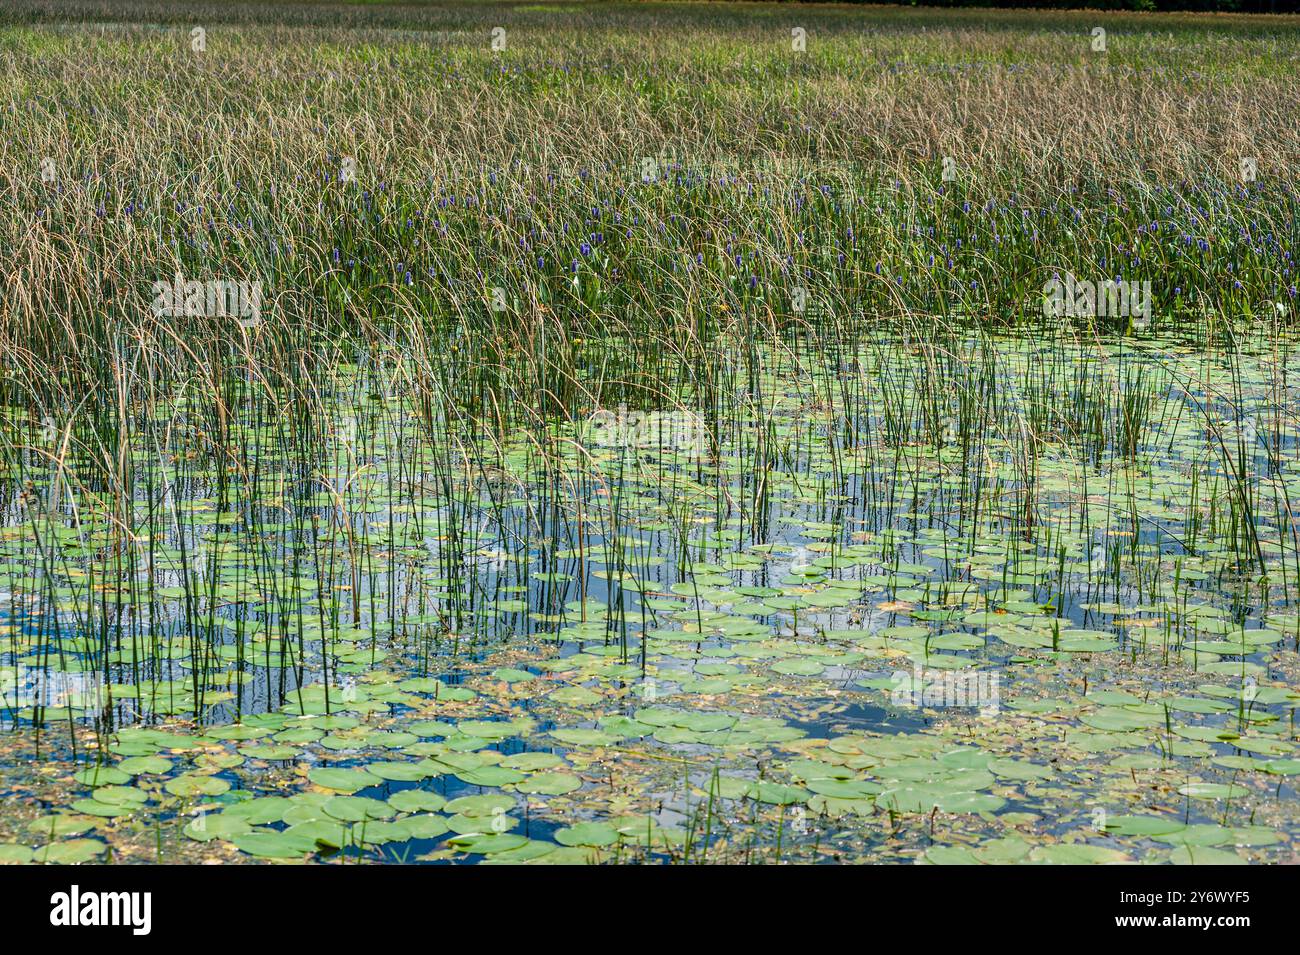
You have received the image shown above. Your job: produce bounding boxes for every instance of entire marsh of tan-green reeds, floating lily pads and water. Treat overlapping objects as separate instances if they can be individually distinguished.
[0,0,1300,863]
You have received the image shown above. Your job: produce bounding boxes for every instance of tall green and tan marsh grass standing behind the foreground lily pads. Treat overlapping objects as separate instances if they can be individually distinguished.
[0,0,1300,859]
